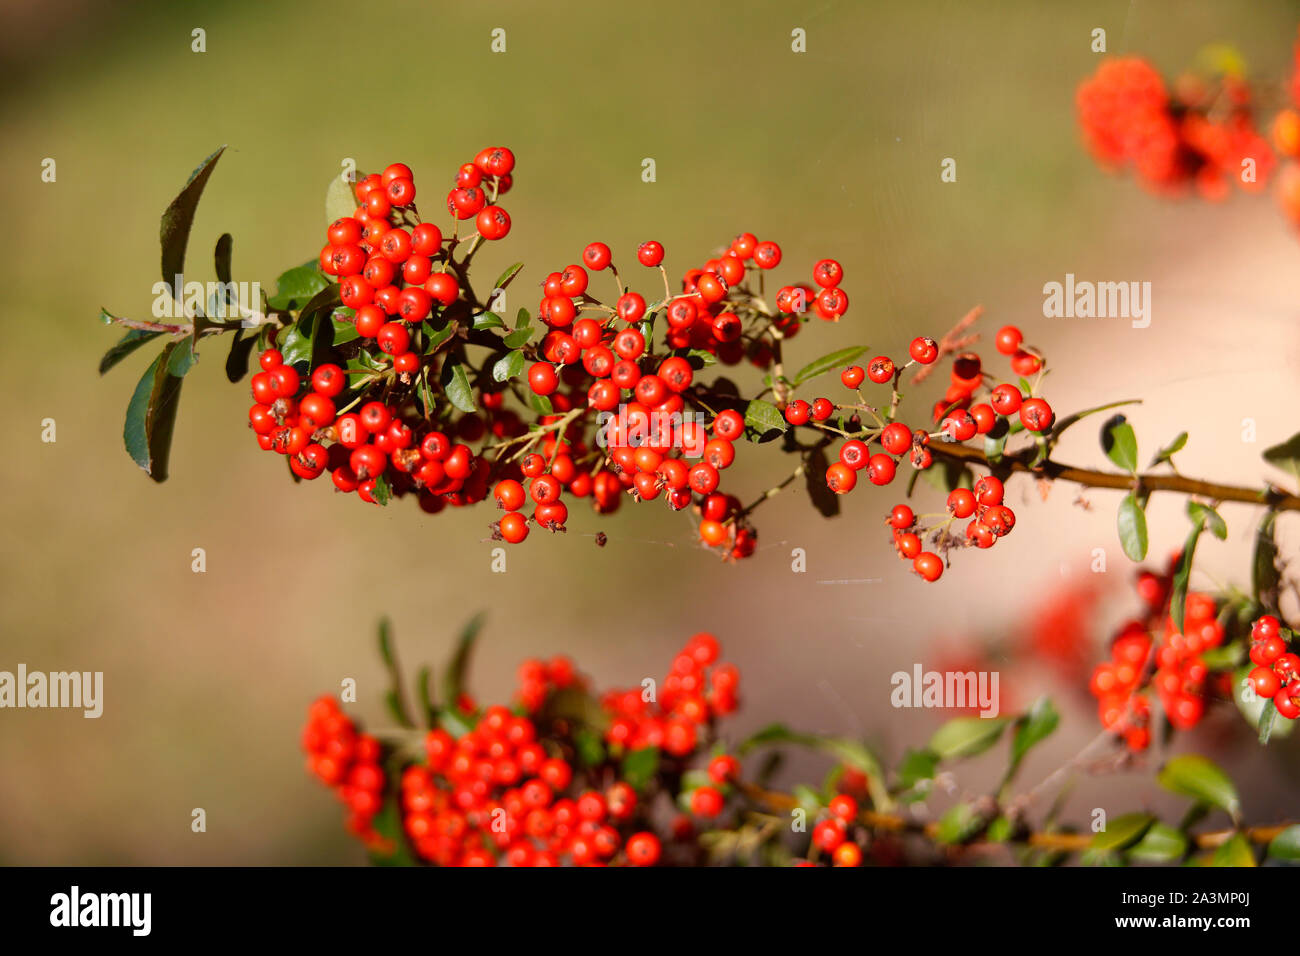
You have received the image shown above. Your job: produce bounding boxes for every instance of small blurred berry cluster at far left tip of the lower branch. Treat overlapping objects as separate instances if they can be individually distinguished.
[302,697,385,845]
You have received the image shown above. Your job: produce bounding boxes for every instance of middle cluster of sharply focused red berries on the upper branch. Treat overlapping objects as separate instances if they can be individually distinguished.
[494,233,848,559]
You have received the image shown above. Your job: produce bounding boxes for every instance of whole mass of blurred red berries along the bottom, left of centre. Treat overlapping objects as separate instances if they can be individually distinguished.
[303,633,740,866]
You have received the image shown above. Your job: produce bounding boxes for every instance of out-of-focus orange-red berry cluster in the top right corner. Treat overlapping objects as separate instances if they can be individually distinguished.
[1076,57,1275,199]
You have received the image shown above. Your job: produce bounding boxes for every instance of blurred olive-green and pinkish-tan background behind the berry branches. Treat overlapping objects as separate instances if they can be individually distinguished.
[0,0,1300,864]
